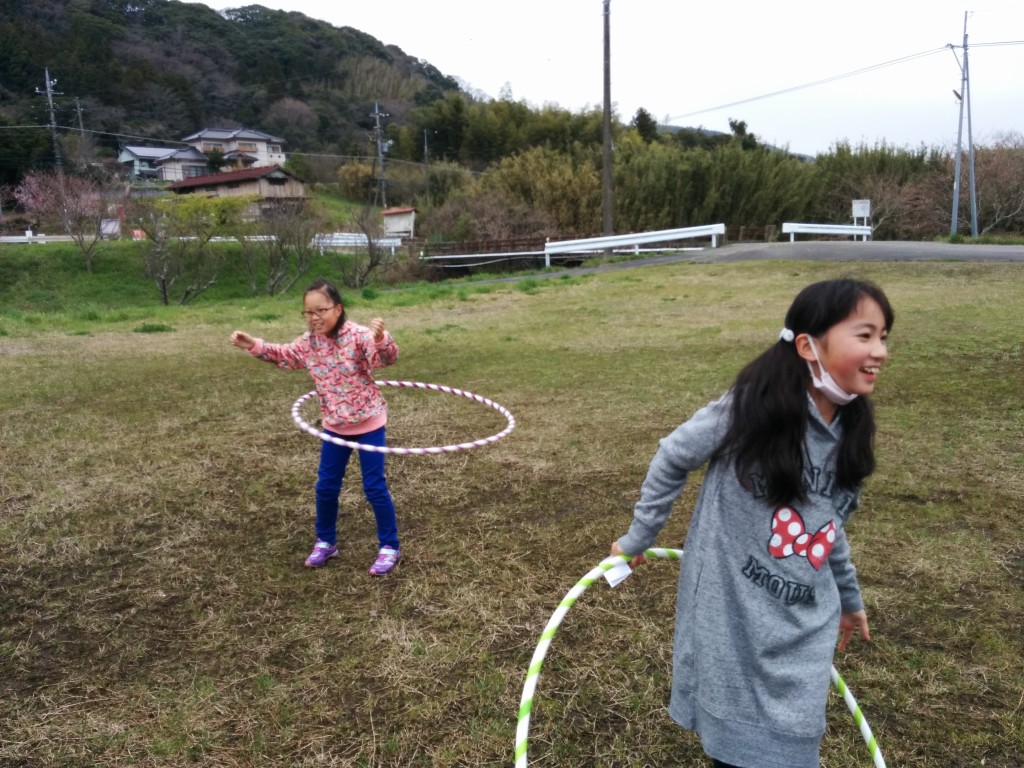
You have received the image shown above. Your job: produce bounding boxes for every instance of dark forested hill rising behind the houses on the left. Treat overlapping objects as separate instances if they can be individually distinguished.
[0,0,459,183]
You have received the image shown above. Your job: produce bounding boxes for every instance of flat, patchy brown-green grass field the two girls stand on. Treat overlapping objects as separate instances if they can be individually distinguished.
[0,256,1024,768]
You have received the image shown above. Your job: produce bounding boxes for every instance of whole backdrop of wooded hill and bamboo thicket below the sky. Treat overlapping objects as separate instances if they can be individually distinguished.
[0,0,1024,249]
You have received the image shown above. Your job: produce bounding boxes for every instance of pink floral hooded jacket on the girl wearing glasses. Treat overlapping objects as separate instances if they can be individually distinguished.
[249,321,398,434]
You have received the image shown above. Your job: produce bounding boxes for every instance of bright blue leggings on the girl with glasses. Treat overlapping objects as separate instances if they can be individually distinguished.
[316,427,398,549]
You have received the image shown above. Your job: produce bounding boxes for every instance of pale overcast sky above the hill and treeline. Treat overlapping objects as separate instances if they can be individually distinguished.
[180,0,1024,155]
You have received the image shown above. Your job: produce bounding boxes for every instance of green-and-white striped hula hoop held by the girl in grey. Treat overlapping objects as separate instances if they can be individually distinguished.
[515,547,886,768]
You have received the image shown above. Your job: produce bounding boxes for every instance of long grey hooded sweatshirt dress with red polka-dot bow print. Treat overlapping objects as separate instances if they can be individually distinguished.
[618,393,863,768]
